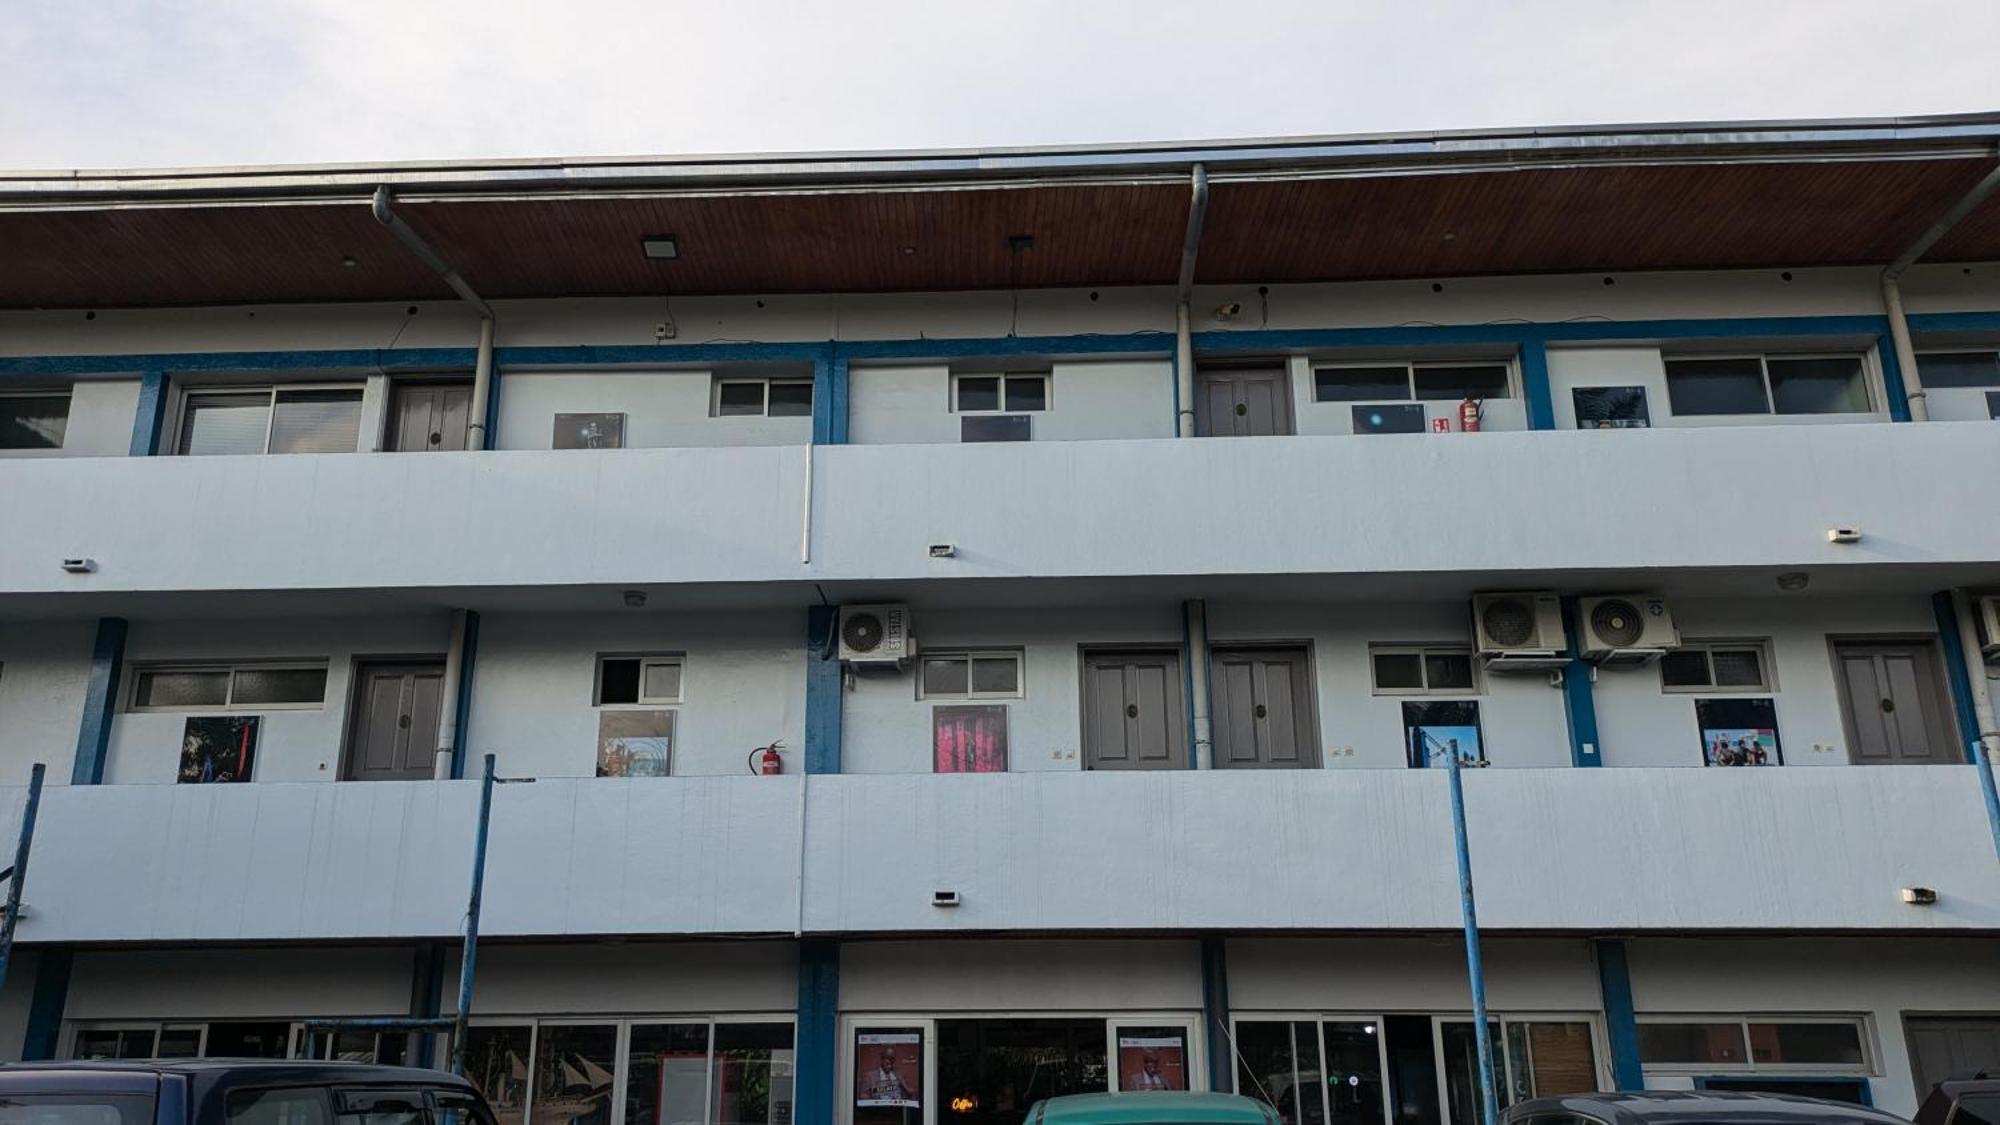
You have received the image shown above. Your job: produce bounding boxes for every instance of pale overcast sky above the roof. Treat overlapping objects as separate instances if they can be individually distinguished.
[0,0,2000,168]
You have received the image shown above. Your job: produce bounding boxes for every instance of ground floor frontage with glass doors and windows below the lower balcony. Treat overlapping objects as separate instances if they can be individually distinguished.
[0,935,2000,1125]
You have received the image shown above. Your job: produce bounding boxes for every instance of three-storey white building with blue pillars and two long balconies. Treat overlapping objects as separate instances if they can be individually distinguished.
[0,118,2000,1125]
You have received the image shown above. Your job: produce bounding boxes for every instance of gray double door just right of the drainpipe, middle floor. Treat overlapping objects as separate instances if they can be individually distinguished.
[1210,649,1320,769]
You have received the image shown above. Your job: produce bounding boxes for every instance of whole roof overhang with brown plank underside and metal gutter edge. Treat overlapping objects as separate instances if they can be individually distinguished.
[0,114,2000,308]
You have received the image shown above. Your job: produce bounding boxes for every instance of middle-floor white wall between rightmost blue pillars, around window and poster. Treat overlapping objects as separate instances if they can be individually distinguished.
[1584,597,1956,767]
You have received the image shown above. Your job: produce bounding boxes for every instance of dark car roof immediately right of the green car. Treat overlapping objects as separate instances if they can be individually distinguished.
[1500,1089,1910,1125]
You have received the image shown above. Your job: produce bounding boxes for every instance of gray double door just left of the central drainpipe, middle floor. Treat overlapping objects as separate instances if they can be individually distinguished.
[1084,649,1188,769]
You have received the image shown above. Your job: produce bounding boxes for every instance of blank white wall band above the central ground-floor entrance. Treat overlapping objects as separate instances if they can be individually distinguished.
[840,939,1202,1013]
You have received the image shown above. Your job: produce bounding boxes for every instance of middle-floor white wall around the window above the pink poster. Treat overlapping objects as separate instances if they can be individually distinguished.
[840,605,1180,773]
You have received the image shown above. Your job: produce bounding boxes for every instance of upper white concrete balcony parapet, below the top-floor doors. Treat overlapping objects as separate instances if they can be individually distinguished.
[0,422,2000,593]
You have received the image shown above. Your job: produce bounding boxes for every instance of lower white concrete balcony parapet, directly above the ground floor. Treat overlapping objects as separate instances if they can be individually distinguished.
[0,767,2000,943]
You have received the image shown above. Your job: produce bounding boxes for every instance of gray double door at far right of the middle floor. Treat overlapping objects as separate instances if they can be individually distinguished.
[1834,641,1964,765]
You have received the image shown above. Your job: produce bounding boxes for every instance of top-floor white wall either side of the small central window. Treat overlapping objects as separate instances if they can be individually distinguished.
[848,360,1174,444]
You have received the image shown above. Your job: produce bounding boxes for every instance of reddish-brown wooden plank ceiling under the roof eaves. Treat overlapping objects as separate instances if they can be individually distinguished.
[0,158,2000,308]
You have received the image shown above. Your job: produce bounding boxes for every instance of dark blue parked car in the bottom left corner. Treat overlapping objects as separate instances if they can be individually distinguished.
[0,1059,494,1125]
